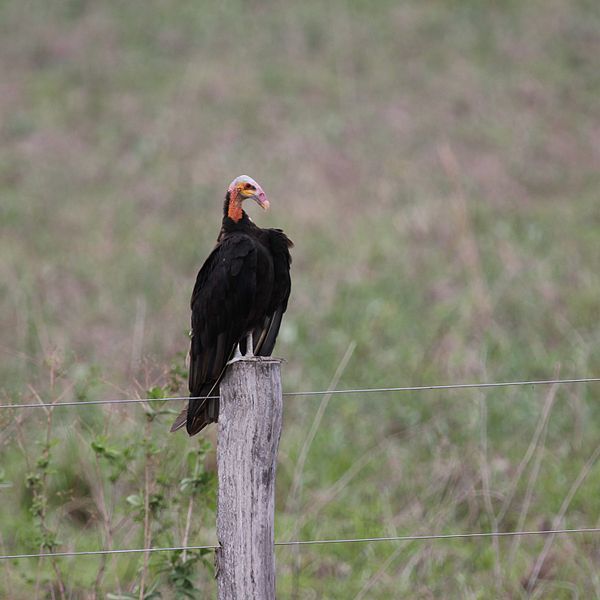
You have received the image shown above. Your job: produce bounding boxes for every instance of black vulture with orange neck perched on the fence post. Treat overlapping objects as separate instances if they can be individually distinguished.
[171,175,293,435]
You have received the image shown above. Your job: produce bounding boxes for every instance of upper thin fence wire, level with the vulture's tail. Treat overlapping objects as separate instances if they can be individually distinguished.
[0,377,600,409]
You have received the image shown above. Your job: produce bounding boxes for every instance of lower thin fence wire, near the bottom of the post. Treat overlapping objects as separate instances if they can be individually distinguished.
[0,527,600,560]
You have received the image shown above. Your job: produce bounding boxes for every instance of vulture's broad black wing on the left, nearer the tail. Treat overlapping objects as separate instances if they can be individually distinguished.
[189,234,257,396]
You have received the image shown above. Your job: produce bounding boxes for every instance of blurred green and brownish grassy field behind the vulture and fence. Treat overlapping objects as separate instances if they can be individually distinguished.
[0,0,600,600]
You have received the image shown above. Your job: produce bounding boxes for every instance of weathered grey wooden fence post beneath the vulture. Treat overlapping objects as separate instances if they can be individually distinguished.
[217,358,283,600]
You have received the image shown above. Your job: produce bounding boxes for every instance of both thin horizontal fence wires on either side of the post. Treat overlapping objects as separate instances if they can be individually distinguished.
[0,377,600,561]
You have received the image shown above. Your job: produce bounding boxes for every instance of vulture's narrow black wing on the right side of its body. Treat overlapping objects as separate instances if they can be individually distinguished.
[253,229,294,356]
